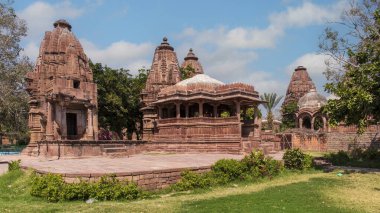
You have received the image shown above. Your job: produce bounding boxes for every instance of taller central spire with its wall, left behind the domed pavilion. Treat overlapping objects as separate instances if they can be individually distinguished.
[141,37,181,140]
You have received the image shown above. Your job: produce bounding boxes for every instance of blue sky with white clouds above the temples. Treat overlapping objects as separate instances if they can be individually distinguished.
[12,0,348,115]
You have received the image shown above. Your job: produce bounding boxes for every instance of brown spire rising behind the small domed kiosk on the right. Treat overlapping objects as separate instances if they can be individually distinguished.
[282,66,315,106]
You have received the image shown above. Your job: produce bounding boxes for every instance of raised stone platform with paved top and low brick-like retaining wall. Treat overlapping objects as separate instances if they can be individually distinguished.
[0,153,243,190]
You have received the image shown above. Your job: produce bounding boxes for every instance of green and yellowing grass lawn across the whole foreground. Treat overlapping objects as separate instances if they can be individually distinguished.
[0,171,380,212]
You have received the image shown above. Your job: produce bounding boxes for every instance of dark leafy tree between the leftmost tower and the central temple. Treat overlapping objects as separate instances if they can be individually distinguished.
[90,62,148,137]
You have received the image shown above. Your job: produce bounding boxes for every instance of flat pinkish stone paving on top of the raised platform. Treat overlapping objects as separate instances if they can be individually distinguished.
[0,153,243,174]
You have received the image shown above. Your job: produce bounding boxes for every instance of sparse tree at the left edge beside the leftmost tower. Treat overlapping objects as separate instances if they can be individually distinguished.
[0,1,32,143]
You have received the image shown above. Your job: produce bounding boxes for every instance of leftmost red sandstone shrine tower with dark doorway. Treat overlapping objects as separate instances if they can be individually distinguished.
[26,20,98,149]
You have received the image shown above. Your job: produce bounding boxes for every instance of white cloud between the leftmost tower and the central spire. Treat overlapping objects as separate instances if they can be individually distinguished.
[80,39,155,71]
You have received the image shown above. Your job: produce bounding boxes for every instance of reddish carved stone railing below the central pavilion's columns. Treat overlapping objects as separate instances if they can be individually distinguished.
[158,116,239,125]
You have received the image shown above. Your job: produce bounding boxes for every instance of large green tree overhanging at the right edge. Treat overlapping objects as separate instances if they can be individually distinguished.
[320,0,380,133]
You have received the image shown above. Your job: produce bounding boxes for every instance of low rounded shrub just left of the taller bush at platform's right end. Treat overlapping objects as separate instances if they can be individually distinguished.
[211,159,244,181]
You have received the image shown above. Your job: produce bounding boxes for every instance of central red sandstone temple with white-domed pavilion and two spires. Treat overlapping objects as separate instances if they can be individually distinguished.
[142,38,262,152]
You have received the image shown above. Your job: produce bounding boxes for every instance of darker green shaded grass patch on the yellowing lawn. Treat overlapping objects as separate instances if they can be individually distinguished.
[181,178,354,212]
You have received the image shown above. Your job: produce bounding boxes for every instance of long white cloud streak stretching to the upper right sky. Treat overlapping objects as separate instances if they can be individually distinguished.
[178,1,347,49]
